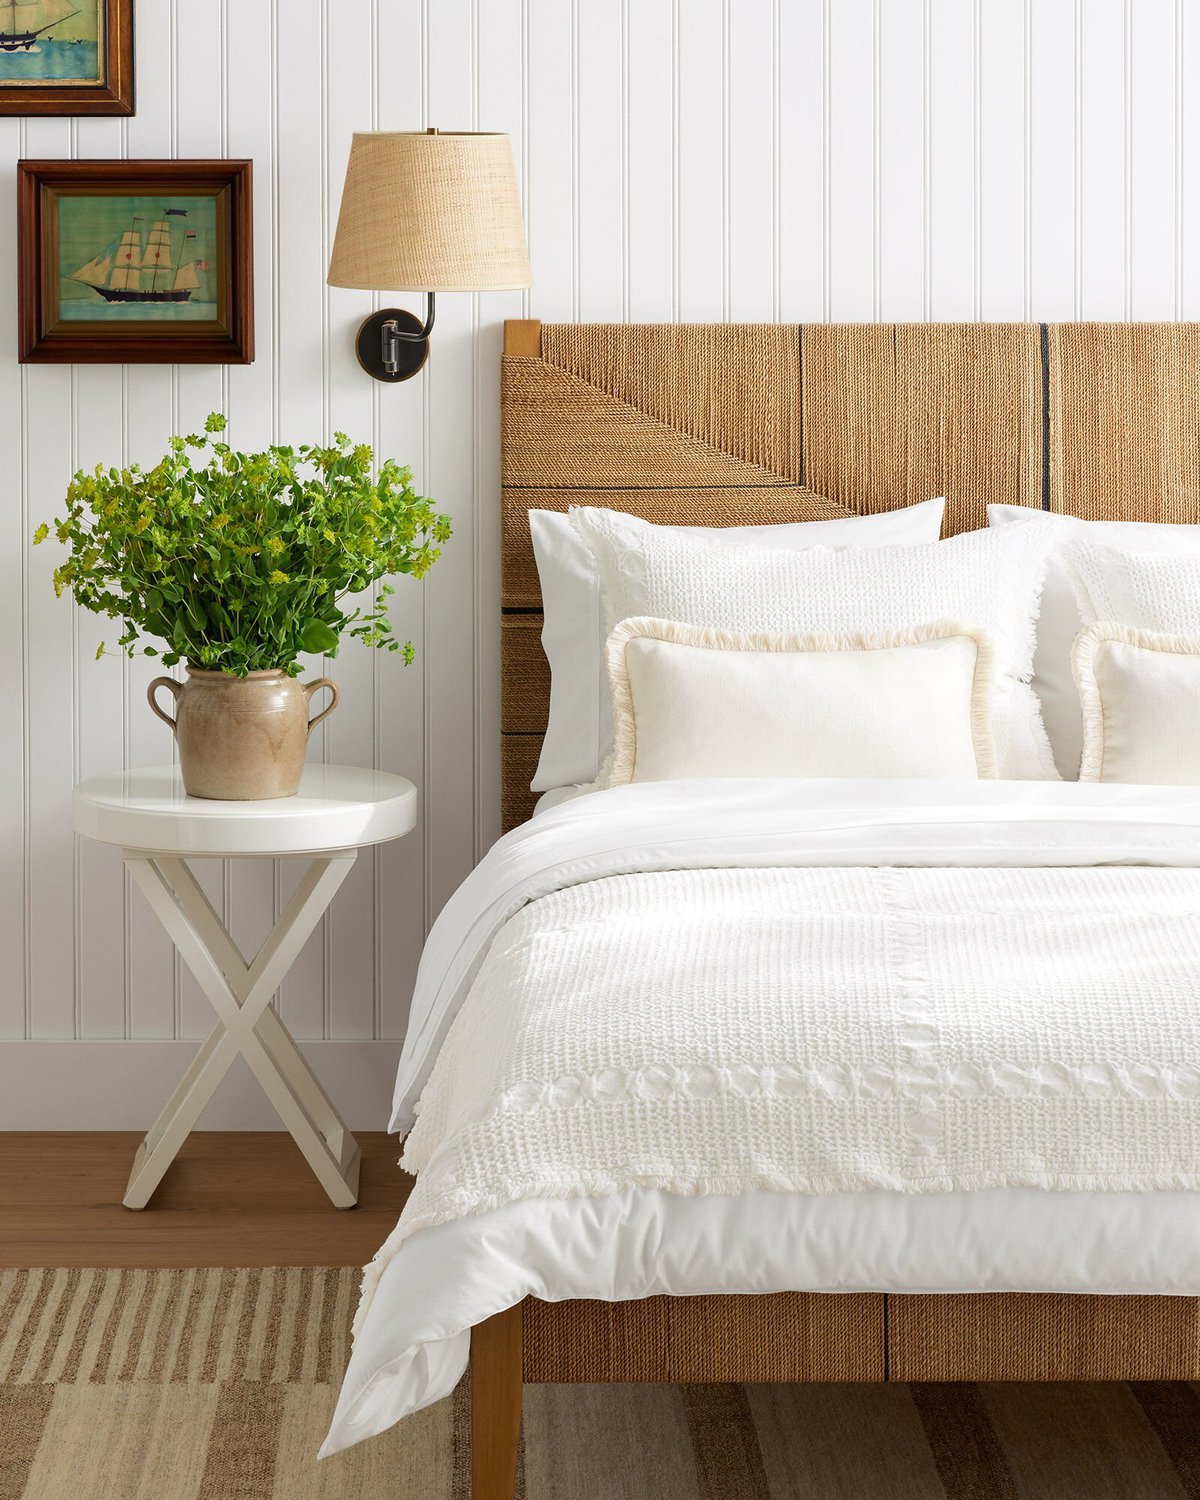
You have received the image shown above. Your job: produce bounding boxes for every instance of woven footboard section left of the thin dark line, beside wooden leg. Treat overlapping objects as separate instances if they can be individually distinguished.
[524,1292,885,1385]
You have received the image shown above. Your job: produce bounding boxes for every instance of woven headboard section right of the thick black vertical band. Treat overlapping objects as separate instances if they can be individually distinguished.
[1049,323,1200,525]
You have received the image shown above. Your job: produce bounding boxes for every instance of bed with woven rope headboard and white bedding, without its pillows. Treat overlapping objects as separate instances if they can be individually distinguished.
[326,323,1200,1500]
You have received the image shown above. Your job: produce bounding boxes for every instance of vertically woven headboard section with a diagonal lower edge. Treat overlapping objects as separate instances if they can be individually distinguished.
[542,323,801,482]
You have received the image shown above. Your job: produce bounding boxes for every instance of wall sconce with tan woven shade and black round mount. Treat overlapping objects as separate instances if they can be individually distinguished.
[327,131,533,381]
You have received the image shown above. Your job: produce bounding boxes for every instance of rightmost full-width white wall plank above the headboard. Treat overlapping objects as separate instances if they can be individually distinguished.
[1127,0,1182,321]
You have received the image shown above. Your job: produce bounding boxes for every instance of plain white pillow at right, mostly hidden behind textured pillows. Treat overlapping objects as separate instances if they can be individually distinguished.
[987,506,1200,782]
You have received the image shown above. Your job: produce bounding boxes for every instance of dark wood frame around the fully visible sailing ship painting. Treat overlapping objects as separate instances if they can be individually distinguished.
[17,161,254,365]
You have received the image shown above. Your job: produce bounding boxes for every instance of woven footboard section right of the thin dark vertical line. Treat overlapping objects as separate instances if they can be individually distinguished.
[888,1293,1200,1380]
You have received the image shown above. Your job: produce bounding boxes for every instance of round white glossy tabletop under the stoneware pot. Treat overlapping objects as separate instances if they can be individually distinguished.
[74,765,417,857]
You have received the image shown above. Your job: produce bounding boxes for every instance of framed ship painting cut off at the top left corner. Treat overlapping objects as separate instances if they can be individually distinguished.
[0,0,133,114]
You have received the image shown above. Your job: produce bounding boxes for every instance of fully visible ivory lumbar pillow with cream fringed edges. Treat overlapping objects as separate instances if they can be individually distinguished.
[608,618,996,786]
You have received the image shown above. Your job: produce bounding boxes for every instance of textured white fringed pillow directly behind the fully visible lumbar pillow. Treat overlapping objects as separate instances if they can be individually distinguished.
[572,510,1058,780]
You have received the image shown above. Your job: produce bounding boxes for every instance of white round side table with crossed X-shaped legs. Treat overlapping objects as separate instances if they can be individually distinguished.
[74,765,417,1209]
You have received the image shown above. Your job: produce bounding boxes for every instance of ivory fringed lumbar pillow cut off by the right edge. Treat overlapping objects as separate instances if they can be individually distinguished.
[1073,621,1200,786]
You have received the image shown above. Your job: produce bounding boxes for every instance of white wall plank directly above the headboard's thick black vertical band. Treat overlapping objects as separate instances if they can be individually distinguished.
[1025,0,1074,323]
